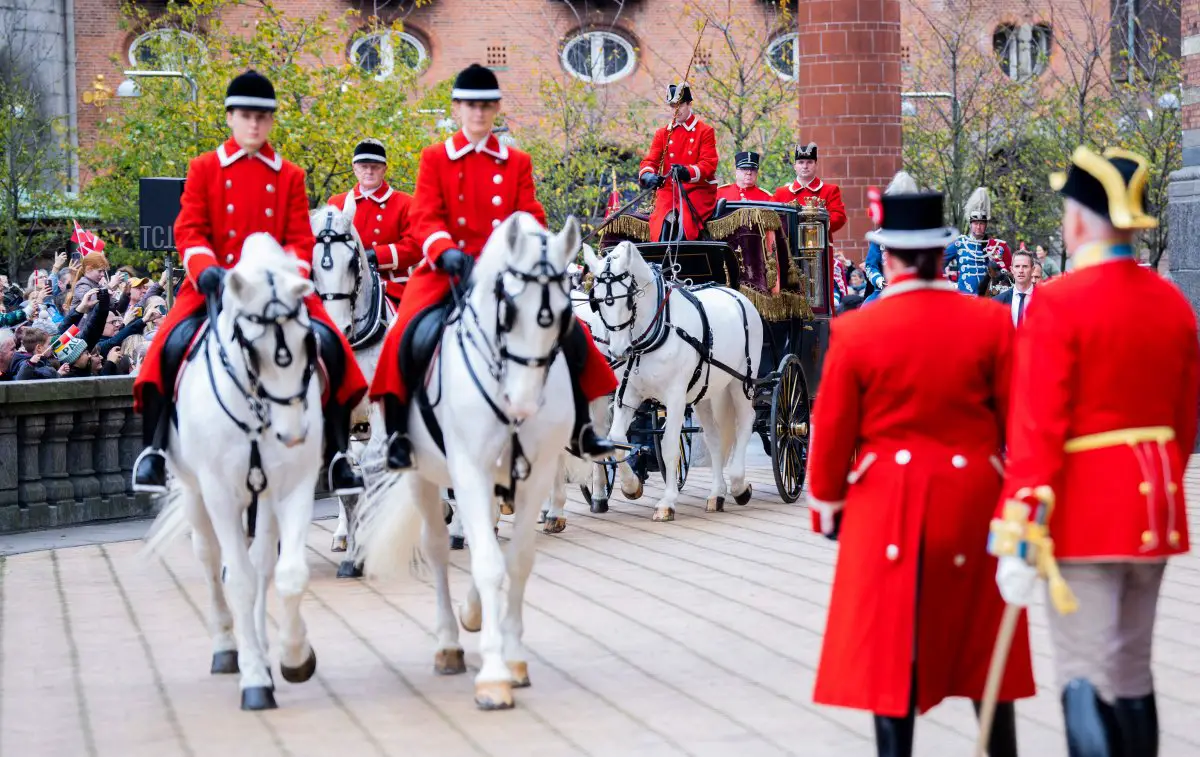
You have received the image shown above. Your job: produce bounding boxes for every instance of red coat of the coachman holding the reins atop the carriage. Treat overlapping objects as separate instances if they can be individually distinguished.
[637,113,718,241]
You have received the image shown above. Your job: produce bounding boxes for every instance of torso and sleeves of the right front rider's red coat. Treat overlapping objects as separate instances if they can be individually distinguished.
[409,131,546,263]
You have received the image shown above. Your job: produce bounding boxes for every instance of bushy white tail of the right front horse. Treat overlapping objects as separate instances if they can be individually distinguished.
[349,459,424,579]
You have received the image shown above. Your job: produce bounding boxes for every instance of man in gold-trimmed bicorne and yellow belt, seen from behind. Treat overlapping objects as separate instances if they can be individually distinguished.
[976,148,1200,757]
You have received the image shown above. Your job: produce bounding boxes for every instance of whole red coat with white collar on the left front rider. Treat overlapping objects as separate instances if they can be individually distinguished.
[133,139,367,409]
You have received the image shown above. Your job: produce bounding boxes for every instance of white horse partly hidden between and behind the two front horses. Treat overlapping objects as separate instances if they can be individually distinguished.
[308,200,396,568]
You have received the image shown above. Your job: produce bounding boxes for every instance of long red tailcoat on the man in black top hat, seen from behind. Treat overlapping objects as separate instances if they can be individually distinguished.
[809,277,1034,716]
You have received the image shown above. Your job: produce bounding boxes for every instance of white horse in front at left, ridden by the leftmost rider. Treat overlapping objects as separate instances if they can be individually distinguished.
[146,234,323,710]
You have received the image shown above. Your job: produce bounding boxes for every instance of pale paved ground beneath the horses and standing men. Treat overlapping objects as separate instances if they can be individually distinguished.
[0,456,1200,757]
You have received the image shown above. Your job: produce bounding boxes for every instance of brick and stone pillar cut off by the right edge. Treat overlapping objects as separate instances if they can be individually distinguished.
[1168,0,1200,451]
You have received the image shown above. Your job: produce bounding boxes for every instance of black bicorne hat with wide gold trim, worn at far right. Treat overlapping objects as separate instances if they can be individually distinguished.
[1050,148,1158,230]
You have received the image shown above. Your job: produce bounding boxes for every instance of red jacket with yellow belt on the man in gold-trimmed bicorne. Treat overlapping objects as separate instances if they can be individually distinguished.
[1001,248,1200,561]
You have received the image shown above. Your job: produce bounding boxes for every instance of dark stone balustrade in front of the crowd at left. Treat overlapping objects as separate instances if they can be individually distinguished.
[0,377,152,533]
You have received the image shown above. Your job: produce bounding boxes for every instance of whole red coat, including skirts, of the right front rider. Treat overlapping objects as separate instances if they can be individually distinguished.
[371,131,617,401]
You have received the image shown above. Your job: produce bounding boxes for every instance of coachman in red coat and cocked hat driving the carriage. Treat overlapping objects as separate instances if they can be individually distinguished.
[637,82,718,242]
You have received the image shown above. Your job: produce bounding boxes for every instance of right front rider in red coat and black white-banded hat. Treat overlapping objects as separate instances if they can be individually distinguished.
[371,64,617,469]
